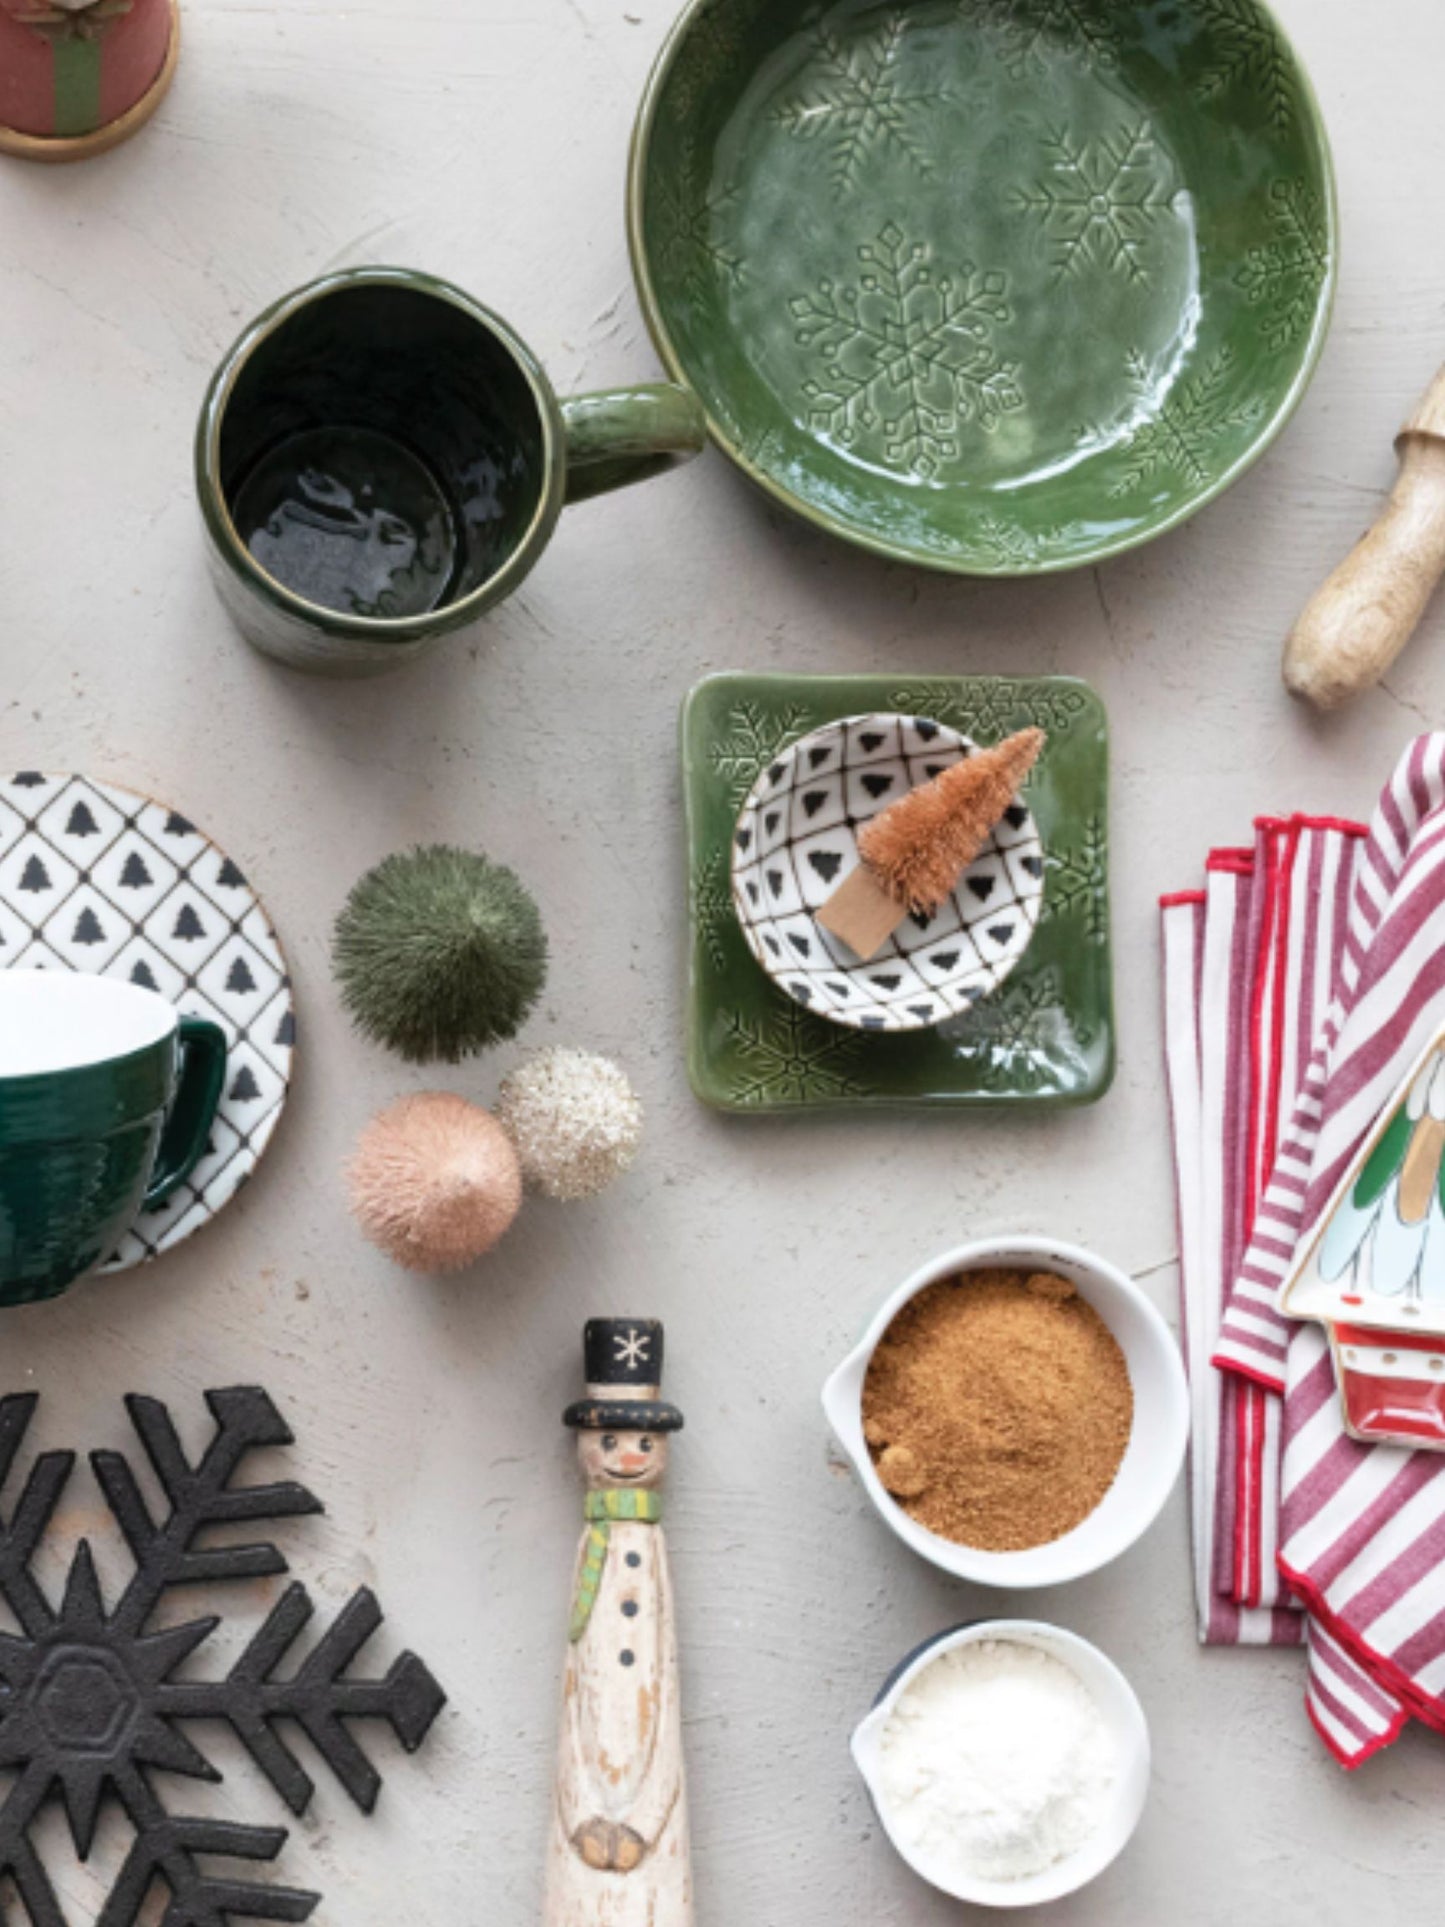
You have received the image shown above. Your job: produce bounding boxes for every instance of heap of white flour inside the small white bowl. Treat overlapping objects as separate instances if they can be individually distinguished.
[880,1640,1117,1881]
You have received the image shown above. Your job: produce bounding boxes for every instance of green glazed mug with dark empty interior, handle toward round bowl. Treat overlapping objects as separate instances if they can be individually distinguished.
[197,268,705,676]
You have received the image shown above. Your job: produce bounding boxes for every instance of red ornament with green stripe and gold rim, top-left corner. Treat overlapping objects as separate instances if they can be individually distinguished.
[0,0,179,160]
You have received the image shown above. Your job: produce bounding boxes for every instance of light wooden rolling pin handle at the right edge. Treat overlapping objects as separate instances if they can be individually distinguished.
[1285,368,1445,709]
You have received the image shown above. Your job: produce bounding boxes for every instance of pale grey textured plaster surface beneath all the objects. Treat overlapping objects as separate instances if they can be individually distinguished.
[0,0,1445,1927]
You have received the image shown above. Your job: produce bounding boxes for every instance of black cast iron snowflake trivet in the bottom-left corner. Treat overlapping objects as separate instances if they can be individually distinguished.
[0,1386,445,1927]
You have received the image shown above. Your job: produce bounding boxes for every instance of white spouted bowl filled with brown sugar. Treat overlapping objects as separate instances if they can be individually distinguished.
[823,1237,1189,1588]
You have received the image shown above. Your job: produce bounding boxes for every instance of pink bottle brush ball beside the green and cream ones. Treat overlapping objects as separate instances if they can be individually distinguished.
[347,1091,522,1274]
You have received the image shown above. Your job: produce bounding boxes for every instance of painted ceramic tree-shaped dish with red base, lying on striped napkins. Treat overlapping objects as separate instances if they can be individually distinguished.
[1281,1029,1445,1451]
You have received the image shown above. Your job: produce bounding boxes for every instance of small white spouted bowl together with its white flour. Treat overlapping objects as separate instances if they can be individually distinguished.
[854,1619,1150,1908]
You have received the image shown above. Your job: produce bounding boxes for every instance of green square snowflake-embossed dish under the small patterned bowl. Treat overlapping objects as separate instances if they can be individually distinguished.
[682,674,1114,1114]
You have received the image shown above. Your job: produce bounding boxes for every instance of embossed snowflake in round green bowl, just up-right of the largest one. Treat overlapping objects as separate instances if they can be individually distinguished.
[1015,121,1177,281]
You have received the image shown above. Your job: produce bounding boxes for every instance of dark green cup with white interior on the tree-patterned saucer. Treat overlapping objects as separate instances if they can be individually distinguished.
[0,969,225,1305]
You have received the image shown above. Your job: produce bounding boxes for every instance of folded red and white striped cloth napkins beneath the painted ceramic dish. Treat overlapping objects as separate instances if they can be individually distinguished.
[1162,736,1445,1765]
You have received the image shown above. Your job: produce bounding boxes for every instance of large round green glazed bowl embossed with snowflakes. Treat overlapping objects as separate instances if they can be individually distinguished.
[628,0,1337,576]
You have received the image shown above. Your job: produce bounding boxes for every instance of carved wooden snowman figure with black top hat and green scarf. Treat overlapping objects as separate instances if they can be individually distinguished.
[543,1318,694,1927]
